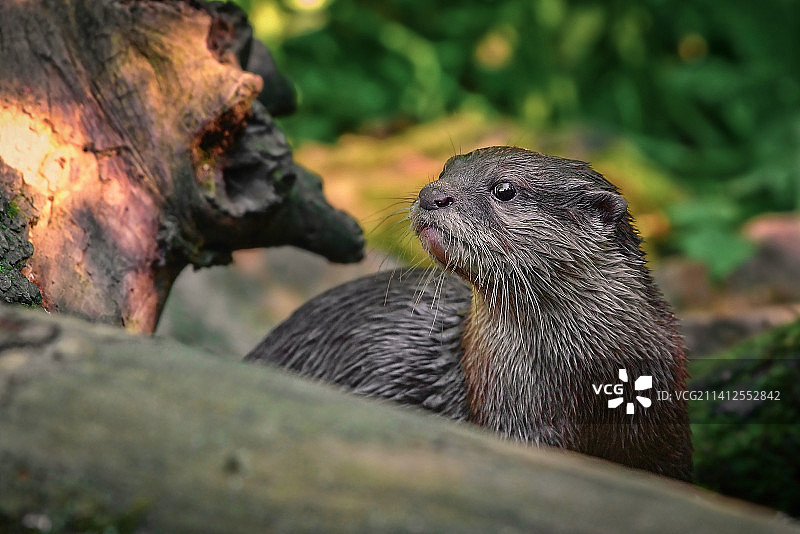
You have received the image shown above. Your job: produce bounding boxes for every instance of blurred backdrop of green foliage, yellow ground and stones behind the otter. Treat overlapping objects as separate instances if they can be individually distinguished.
[159,0,800,357]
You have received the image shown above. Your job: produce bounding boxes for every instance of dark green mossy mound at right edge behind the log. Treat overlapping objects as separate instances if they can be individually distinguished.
[689,321,800,515]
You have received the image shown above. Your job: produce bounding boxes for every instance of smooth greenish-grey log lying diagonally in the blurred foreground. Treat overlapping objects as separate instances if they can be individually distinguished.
[0,306,797,533]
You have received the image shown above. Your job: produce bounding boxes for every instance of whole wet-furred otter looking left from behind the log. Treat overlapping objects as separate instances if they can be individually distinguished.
[246,147,692,486]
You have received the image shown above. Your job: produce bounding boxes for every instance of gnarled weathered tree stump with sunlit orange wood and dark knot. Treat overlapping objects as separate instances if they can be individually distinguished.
[0,0,362,332]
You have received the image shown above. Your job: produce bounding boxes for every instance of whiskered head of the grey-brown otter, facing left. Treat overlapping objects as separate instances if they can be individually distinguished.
[411,147,644,308]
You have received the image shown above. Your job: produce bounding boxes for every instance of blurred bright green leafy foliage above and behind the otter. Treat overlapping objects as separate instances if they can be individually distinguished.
[234,0,800,274]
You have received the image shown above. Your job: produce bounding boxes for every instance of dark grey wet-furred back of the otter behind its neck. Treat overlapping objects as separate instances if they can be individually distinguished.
[245,269,471,420]
